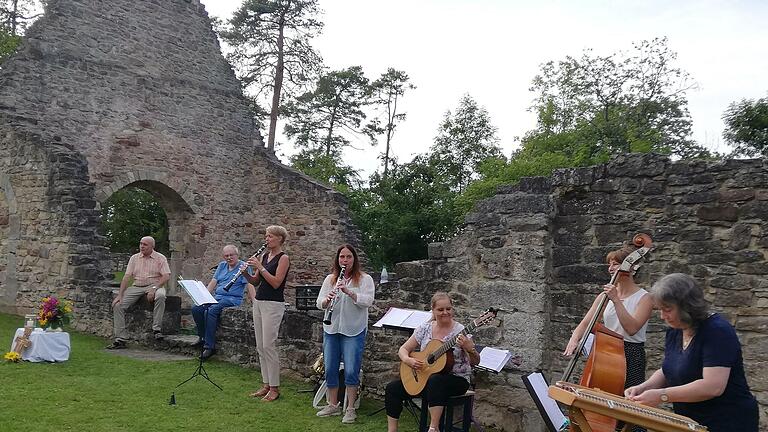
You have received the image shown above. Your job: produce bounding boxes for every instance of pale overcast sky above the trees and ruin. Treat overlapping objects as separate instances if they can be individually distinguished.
[201,0,768,177]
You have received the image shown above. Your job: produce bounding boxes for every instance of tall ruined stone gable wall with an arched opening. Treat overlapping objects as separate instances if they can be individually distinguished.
[0,0,359,335]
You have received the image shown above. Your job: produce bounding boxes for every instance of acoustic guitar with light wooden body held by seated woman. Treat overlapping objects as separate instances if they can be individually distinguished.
[400,308,498,396]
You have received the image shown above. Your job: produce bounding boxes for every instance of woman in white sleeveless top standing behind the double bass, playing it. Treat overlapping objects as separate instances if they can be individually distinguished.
[563,246,653,430]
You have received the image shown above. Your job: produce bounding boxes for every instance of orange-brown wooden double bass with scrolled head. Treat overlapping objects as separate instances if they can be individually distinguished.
[560,233,653,432]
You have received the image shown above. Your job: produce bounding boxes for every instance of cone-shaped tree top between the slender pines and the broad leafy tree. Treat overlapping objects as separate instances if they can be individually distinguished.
[429,94,502,193]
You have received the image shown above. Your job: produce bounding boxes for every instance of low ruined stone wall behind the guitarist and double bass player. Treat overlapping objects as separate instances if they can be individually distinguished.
[356,155,768,431]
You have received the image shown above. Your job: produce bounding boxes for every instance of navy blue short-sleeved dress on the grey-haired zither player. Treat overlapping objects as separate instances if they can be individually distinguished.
[662,314,758,432]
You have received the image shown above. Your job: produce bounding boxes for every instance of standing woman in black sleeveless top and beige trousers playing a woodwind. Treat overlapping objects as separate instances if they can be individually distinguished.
[243,225,291,402]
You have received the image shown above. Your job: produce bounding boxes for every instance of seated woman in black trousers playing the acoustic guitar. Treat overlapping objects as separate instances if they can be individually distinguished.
[384,292,480,432]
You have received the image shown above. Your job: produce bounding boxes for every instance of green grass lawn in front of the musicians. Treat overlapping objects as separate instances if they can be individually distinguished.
[0,314,416,432]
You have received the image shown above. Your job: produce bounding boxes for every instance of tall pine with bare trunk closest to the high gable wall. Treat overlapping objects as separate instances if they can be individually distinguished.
[219,0,323,150]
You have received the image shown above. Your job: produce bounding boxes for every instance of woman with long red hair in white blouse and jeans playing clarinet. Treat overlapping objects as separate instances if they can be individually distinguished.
[317,244,375,423]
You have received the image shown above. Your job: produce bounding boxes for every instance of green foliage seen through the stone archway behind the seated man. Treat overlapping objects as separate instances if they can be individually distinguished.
[101,187,170,254]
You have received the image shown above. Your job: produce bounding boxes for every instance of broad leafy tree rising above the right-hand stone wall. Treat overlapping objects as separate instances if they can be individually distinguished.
[523,38,708,164]
